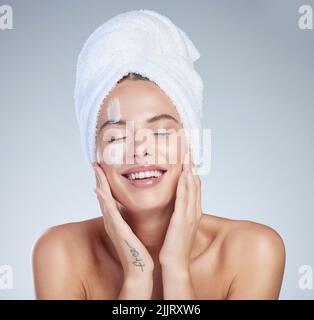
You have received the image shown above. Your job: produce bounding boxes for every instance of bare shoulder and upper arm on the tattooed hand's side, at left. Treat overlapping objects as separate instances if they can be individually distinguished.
[32,219,101,299]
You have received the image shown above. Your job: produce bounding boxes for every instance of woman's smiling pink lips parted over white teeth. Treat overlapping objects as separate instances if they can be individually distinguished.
[121,165,167,188]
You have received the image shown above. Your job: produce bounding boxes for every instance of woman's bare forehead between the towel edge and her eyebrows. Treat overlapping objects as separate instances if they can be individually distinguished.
[98,79,180,125]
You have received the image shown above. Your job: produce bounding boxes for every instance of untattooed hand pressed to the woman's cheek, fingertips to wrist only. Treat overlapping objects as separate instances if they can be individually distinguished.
[159,150,202,273]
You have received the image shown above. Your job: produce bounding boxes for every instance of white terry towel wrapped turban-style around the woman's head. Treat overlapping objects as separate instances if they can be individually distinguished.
[74,9,203,166]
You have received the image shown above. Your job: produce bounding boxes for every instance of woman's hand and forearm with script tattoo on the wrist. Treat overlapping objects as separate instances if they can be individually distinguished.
[93,162,154,299]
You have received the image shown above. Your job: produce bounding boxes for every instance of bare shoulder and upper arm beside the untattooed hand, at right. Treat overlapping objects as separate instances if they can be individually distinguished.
[200,215,285,299]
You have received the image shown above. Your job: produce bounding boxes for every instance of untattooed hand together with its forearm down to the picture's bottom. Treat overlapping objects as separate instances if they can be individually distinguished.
[159,151,202,300]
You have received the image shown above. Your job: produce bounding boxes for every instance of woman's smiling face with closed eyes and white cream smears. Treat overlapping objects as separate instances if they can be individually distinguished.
[96,79,186,212]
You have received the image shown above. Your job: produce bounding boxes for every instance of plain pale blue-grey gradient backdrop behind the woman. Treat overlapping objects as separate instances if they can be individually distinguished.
[0,0,314,299]
